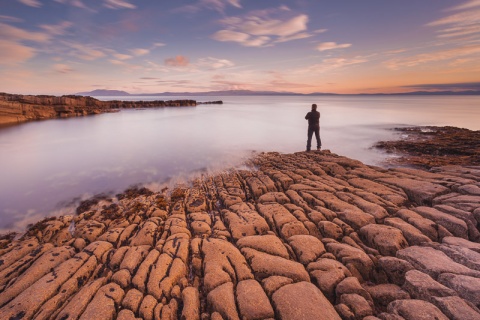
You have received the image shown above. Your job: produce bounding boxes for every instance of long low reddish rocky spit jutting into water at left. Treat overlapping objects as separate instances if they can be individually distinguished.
[0,93,197,125]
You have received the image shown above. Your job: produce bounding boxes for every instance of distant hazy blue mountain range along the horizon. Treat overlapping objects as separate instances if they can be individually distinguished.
[75,89,480,97]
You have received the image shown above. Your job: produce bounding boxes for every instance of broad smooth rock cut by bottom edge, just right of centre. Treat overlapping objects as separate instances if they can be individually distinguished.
[272,282,341,320]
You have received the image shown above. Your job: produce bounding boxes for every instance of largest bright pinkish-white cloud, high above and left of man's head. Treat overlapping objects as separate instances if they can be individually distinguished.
[212,8,312,47]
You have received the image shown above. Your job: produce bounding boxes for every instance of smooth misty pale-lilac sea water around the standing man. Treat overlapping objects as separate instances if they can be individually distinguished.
[0,96,480,232]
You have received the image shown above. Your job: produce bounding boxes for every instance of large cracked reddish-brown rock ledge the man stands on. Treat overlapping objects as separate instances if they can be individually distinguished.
[0,151,480,320]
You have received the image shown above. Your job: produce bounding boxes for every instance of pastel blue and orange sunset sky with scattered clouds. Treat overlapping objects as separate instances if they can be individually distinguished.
[0,0,480,94]
